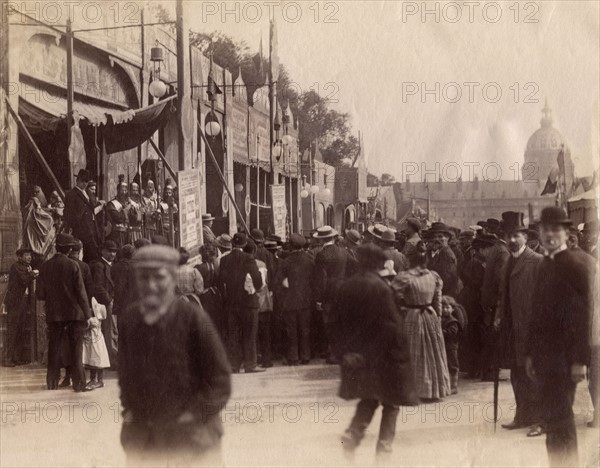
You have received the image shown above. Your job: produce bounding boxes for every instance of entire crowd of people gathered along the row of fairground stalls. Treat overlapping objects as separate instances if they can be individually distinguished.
[5,171,600,466]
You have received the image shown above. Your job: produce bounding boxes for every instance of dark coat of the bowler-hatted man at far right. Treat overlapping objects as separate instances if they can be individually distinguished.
[526,249,595,378]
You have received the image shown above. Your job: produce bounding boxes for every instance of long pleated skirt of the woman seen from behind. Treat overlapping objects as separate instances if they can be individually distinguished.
[402,307,450,399]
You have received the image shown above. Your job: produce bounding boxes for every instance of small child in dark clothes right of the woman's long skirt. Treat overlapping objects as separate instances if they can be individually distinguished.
[442,296,466,395]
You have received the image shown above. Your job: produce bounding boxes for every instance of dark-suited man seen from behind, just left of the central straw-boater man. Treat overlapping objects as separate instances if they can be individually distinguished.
[275,234,314,366]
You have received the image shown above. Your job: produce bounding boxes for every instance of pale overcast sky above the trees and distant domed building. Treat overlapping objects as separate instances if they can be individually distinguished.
[164,1,600,181]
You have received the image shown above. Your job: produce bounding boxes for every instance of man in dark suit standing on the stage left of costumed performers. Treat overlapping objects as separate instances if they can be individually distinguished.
[63,169,100,263]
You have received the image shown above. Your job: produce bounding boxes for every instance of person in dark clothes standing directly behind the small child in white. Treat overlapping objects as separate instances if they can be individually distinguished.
[90,240,118,367]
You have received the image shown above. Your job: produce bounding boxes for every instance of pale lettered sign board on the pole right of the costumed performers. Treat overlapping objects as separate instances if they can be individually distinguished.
[177,169,203,255]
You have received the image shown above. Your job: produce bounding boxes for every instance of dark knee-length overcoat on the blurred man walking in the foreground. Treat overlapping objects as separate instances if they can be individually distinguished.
[333,272,418,406]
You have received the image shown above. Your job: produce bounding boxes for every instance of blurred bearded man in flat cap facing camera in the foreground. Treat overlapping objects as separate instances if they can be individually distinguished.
[119,245,231,466]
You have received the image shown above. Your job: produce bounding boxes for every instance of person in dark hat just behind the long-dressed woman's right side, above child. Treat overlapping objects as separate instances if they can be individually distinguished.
[427,222,458,297]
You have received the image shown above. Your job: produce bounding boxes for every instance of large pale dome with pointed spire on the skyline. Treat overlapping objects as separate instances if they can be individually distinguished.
[521,101,574,196]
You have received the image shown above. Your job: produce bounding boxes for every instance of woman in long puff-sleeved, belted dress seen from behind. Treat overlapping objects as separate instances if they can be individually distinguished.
[392,241,450,400]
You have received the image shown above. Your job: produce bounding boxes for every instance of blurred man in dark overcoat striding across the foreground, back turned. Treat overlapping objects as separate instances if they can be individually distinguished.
[333,244,418,457]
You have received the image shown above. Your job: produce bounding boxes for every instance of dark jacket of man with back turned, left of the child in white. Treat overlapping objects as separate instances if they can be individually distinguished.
[37,253,92,322]
